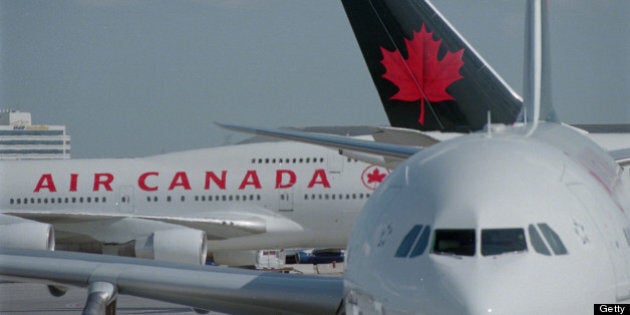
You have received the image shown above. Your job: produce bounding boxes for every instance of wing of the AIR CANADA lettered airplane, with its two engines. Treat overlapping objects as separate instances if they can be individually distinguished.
[0,206,304,264]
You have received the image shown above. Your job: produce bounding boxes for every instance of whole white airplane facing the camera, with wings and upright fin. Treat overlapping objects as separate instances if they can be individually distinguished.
[0,0,630,314]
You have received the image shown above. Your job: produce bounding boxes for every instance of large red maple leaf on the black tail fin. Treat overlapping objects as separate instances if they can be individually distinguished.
[381,24,464,125]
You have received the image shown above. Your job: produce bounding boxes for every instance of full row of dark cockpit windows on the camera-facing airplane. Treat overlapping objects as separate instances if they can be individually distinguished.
[395,223,568,258]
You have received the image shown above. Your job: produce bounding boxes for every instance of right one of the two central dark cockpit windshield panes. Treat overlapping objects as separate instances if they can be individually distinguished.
[481,228,527,256]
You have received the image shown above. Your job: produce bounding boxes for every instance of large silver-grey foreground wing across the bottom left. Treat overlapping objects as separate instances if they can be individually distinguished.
[0,248,343,314]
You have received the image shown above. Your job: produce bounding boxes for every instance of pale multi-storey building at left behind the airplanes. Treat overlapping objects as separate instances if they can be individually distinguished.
[0,110,70,160]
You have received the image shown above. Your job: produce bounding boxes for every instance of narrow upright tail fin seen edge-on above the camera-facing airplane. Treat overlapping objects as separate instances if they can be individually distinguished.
[522,0,557,135]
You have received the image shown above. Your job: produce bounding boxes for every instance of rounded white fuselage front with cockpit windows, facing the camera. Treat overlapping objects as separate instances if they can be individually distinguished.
[345,123,630,314]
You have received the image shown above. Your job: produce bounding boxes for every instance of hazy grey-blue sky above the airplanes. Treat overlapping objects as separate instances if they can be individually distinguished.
[0,0,630,158]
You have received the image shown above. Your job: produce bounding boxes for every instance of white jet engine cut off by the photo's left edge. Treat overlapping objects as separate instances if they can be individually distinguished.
[0,215,55,250]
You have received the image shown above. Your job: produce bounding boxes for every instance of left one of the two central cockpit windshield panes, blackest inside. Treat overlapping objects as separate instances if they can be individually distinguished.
[433,229,475,256]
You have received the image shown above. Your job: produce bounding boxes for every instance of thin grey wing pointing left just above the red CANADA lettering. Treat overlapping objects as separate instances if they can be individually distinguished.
[217,123,422,165]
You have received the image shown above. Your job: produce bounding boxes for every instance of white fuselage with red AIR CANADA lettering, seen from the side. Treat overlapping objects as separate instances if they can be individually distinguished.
[0,142,387,262]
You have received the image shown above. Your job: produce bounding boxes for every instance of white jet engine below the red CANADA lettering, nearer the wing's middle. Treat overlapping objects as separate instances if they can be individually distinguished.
[135,228,208,265]
